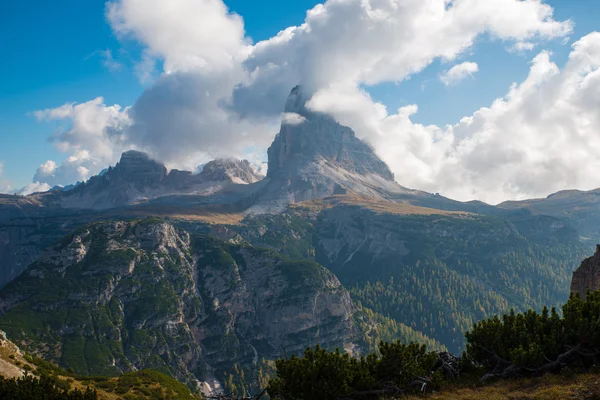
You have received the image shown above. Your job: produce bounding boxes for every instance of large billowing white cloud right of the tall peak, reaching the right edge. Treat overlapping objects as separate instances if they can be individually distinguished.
[309,32,600,203]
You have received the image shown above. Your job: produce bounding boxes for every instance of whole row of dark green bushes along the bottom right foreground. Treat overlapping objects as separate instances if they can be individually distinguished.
[268,292,600,400]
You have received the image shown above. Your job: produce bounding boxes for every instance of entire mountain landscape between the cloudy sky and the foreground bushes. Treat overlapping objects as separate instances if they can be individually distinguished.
[0,87,600,392]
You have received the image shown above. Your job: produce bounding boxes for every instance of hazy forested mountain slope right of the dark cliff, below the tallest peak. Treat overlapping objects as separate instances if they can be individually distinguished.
[232,196,588,352]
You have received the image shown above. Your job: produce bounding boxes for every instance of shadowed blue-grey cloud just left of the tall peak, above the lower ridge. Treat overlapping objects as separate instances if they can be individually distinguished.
[128,70,278,168]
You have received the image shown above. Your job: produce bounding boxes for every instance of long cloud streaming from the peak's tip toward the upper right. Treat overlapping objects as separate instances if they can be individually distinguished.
[233,0,572,117]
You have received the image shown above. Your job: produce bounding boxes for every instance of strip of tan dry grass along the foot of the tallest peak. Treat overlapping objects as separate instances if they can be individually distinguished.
[292,194,470,215]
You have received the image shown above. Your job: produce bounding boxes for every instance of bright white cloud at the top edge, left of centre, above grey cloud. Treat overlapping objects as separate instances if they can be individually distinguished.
[106,0,247,72]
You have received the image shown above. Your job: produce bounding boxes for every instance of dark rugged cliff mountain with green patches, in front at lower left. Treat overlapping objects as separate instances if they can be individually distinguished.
[0,220,359,390]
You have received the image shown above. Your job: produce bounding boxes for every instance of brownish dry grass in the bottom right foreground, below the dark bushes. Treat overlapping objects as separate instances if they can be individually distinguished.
[398,373,600,400]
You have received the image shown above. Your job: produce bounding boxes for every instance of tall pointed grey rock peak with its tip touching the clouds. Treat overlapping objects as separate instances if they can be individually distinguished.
[251,86,417,213]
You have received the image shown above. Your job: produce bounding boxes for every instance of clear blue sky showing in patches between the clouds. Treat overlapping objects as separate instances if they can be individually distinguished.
[0,0,600,200]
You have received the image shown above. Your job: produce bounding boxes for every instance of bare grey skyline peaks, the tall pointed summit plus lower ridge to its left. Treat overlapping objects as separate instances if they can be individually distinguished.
[16,86,426,213]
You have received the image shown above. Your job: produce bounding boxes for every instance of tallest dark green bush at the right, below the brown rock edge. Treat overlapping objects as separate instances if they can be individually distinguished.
[466,292,600,373]
